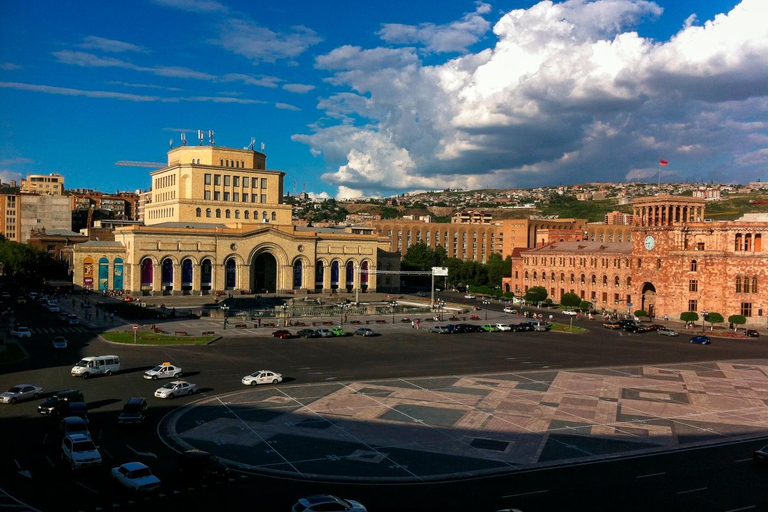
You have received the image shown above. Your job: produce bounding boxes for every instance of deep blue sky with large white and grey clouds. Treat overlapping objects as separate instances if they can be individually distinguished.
[0,0,768,197]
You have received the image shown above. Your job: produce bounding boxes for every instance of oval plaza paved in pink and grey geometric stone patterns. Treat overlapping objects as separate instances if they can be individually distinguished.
[159,360,768,481]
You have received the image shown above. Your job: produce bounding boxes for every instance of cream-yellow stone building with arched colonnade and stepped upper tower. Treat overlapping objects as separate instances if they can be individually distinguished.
[74,146,400,295]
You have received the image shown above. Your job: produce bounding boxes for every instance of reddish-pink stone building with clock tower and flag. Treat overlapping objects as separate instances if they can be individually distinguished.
[503,196,768,327]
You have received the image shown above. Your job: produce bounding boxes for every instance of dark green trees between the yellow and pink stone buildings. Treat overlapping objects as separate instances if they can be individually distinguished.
[401,242,512,294]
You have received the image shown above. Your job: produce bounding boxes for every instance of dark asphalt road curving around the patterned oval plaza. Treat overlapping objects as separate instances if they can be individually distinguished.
[0,296,768,512]
